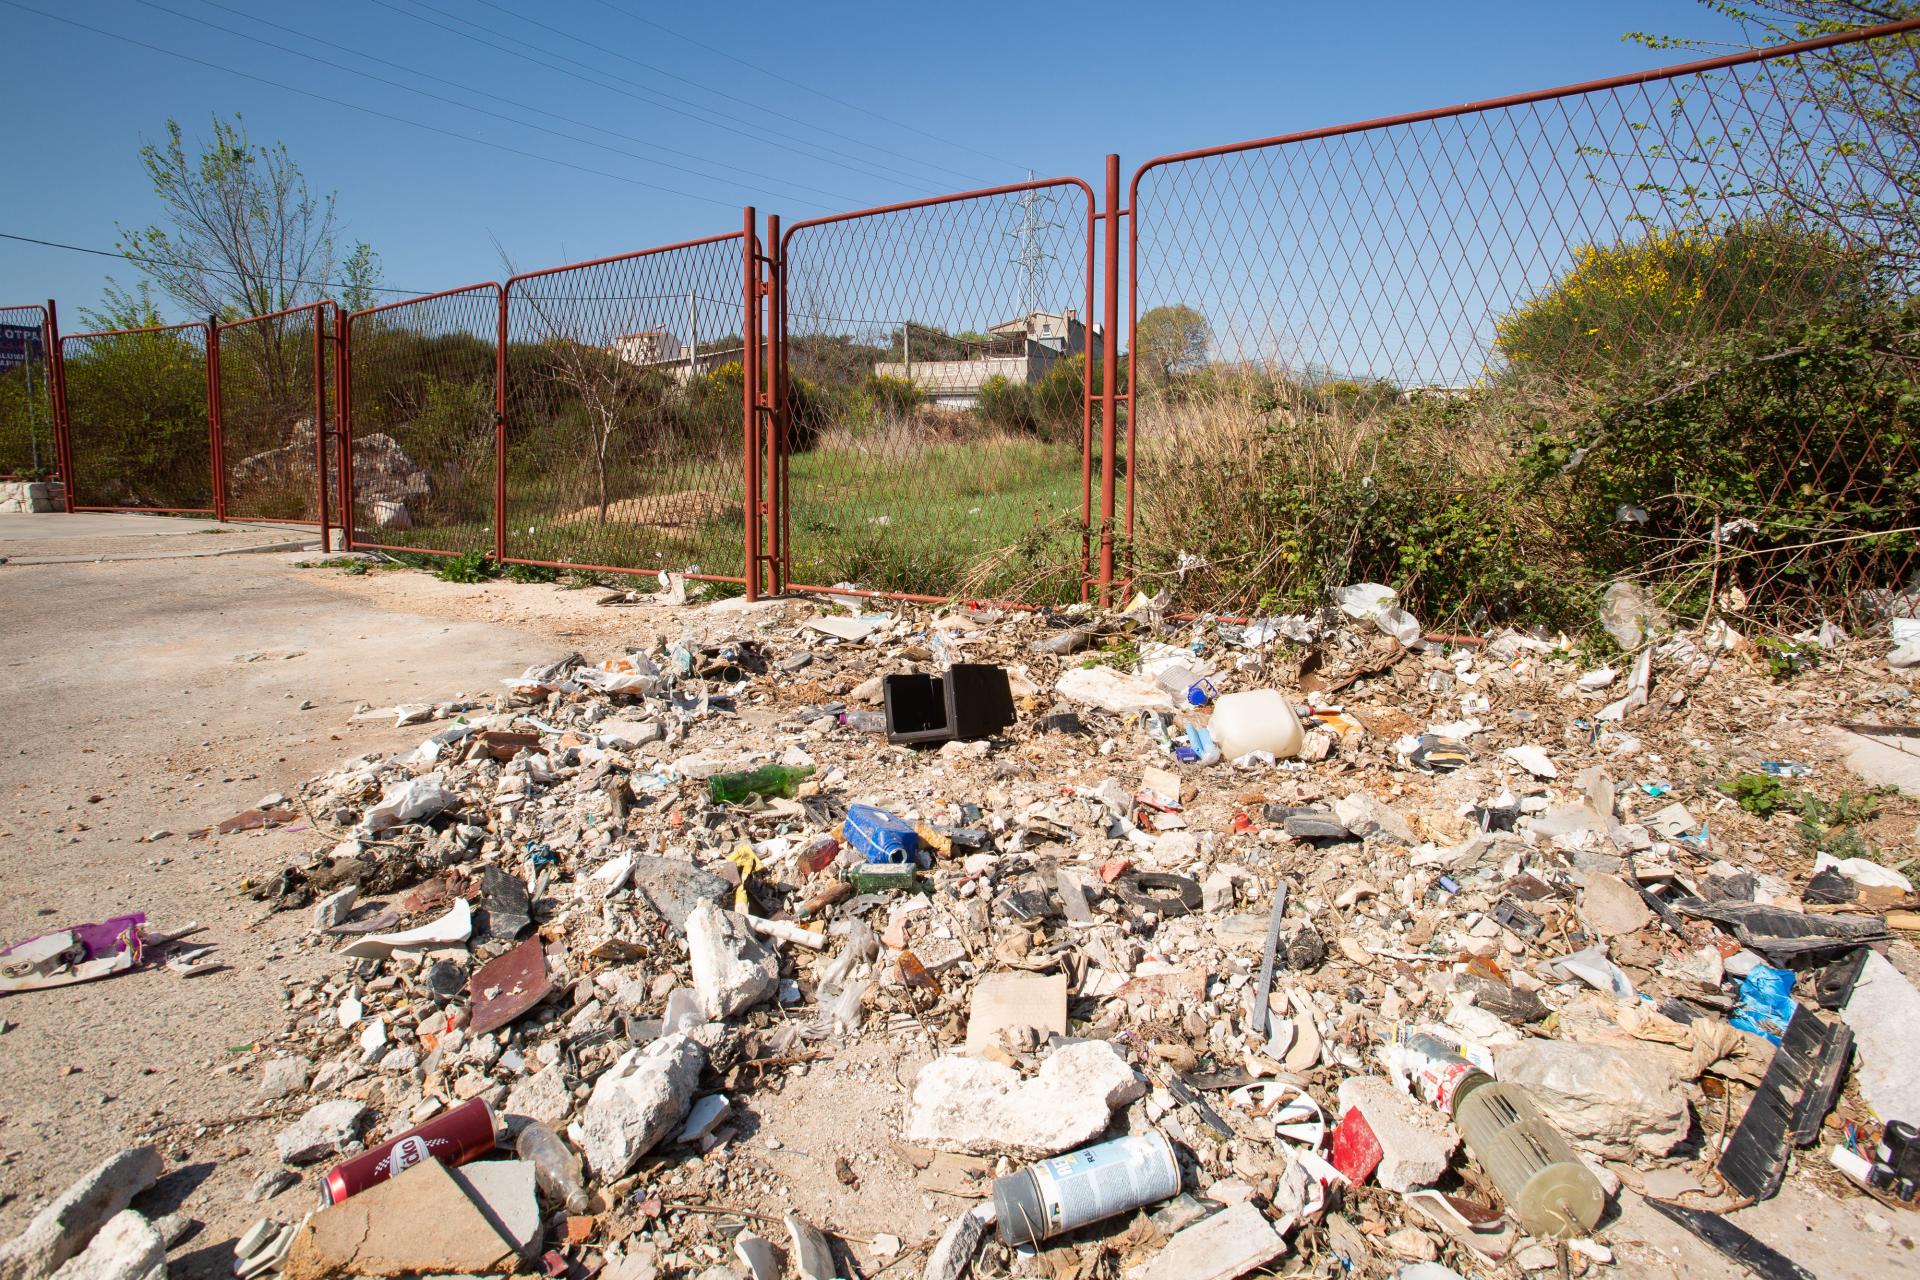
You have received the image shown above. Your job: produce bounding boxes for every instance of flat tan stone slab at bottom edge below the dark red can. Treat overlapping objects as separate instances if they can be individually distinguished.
[280,1159,518,1280]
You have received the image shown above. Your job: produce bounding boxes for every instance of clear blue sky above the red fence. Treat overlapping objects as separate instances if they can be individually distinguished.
[0,0,1758,320]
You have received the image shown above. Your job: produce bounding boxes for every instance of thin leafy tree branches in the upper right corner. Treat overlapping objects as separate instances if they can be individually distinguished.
[1626,0,1920,278]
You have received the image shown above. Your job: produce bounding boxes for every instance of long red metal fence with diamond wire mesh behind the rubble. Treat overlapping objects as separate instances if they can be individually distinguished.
[15,19,1920,620]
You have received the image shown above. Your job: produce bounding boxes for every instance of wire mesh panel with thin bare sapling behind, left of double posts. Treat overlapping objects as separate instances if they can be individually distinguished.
[505,234,745,580]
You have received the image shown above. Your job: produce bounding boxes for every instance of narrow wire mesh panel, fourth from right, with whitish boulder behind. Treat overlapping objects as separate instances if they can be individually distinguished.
[348,284,499,555]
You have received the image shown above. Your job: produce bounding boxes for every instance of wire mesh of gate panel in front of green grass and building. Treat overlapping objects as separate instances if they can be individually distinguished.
[783,180,1098,601]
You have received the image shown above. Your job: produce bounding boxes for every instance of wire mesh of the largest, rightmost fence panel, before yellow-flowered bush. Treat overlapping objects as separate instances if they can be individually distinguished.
[1127,33,1920,620]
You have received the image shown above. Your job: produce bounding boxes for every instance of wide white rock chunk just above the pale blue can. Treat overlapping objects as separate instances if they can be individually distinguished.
[904,1040,1146,1159]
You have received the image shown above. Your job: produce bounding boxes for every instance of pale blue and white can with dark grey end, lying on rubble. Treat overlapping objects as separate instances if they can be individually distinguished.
[993,1132,1181,1247]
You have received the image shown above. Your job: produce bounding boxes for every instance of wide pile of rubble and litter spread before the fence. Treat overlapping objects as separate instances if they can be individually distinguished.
[3,589,1920,1280]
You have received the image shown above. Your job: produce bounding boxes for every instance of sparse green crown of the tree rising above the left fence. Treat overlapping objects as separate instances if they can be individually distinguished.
[117,115,380,319]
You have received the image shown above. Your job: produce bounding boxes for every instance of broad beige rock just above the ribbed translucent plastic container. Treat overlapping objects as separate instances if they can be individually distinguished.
[1494,1040,1690,1159]
